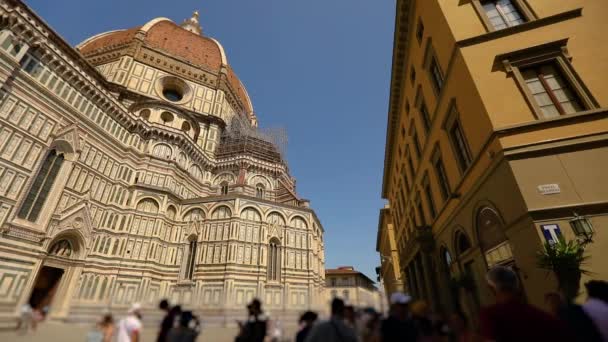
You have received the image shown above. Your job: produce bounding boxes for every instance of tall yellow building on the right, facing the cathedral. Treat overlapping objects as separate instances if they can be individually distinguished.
[382,0,608,317]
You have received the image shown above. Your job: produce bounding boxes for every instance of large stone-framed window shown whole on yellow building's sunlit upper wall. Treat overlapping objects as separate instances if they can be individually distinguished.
[496,39,599,119]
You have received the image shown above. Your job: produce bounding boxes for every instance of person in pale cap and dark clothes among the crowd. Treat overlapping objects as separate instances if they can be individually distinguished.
[380,292,418,342]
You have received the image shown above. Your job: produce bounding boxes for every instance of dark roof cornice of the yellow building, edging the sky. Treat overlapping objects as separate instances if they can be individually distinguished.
[382,0,416,198]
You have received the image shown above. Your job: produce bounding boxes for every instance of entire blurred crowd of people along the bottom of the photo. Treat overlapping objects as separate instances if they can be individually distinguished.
[18,266,608,342]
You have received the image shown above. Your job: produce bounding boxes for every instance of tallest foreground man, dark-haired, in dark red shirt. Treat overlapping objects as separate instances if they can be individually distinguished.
[480,266,576,342]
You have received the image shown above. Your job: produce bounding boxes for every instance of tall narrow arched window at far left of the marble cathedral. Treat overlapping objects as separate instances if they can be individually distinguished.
[17,149,64,222]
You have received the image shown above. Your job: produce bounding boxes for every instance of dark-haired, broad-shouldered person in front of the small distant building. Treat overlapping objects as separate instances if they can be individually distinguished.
[305,298,357,342]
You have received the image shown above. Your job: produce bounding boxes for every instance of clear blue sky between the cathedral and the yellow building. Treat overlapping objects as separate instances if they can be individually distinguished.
[26,0,395,279]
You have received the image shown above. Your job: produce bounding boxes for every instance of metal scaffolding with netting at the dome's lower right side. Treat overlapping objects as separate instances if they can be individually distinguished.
[216,114,287,165]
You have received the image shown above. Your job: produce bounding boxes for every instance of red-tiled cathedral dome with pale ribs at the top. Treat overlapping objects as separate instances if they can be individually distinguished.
[77,12,253,114]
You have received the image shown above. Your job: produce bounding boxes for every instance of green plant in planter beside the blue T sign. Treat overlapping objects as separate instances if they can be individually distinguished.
[536,237,589,302]
